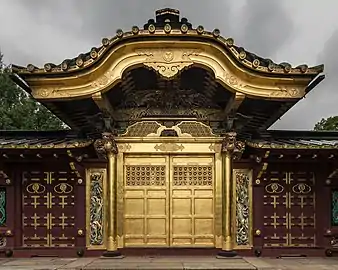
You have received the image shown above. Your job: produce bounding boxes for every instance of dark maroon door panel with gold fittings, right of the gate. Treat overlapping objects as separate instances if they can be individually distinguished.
[263,171,315,247]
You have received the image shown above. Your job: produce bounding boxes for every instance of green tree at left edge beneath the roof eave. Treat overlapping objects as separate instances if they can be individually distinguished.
[0,53,67,130]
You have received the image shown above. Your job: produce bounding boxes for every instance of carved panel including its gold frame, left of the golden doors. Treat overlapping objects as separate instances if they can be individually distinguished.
[86,168,107,249]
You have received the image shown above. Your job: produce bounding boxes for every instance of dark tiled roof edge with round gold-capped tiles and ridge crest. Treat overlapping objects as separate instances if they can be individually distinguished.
[12,8,324,77]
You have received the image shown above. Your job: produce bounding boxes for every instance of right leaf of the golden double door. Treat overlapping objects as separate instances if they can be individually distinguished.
[170,156,215,247]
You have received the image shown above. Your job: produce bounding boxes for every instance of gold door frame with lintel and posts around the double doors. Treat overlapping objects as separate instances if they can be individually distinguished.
[116,137,223,248]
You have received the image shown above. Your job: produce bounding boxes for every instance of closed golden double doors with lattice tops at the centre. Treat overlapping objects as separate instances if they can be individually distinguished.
[123,155,215,247]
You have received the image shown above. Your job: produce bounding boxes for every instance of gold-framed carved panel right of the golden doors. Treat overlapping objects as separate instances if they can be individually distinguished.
[233,169,252,248]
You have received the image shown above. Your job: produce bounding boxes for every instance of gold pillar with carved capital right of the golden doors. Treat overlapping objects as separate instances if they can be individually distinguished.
[219,132,245,257]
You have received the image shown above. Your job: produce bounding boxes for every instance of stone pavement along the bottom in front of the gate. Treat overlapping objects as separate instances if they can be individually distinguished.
[0,256,338,270]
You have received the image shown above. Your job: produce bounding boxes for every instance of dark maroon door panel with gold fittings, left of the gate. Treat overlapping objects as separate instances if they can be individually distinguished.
[22,171,76,247]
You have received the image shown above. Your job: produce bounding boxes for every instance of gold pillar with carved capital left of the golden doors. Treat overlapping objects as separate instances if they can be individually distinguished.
[95,133,121,257]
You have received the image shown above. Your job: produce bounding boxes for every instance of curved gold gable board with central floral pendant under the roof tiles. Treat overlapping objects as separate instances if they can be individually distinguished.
[27,41,308,99]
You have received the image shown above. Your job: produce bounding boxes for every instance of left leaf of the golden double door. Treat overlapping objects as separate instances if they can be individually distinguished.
[124,157,169,247]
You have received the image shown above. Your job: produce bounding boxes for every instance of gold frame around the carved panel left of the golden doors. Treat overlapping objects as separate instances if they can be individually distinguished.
[86,168,107,249]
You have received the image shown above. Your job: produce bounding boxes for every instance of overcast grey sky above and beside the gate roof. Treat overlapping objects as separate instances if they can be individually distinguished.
[0,0,338,129]
